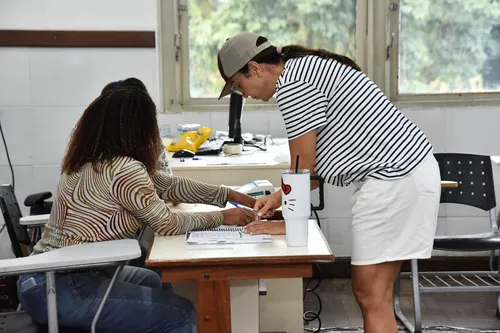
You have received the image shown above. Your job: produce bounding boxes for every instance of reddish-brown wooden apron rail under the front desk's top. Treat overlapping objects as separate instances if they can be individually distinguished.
[161,264,312,283]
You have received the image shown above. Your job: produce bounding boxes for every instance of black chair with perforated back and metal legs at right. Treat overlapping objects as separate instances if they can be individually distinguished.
[394,153,500,332]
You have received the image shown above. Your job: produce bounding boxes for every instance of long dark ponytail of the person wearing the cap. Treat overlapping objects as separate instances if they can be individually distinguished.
[239,36,361,74]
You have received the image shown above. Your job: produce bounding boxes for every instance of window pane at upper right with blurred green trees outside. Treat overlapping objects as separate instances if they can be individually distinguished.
[389,0,500,104]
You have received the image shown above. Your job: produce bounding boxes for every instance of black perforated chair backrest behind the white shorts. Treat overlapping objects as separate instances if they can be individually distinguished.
[434,153,496,211]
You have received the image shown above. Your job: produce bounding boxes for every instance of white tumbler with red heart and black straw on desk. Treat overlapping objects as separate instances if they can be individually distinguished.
[281,170,311,246]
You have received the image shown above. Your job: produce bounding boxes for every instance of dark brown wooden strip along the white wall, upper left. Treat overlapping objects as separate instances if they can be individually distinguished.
[0,30,155,48]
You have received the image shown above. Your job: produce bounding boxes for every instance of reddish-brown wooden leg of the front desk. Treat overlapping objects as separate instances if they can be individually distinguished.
[197,281,231,333]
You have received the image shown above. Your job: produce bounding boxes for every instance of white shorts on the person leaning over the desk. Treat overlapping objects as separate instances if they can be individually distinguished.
[351,154,441,265]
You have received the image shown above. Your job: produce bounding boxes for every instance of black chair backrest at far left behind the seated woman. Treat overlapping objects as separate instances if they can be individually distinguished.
[0,185,31,257]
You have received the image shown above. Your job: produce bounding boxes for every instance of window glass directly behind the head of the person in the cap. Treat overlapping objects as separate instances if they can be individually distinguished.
[188,0,356,98]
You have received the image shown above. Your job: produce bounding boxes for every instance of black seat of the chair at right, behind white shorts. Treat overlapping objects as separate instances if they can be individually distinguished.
[434,232,500,252]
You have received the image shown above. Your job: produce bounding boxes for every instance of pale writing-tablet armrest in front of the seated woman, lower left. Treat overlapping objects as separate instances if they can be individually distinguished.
[0,239,141,276]
